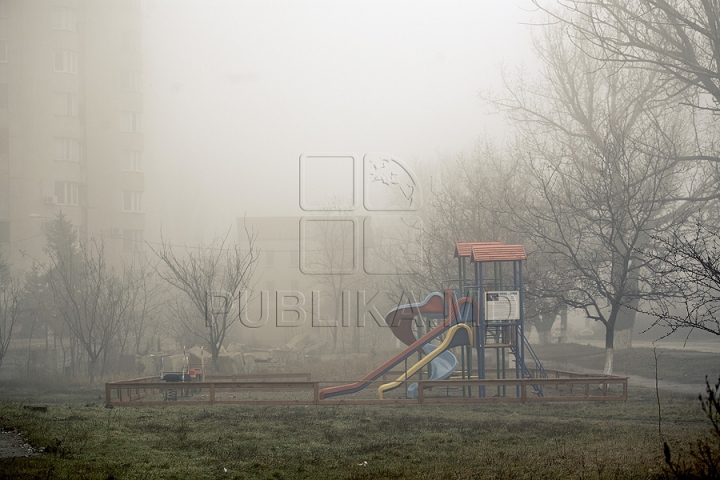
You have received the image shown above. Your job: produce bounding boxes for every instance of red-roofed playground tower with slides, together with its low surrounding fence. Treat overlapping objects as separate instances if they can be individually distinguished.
[106,242,627,405]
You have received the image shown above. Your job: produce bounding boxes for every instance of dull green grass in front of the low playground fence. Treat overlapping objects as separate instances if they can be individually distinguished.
[0,389,709,479]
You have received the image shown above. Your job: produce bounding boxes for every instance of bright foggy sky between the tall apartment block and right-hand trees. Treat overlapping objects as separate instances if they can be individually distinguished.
[143,0,533,242]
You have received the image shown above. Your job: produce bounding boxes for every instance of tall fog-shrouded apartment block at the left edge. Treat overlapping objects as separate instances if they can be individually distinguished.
[0,0,145,268]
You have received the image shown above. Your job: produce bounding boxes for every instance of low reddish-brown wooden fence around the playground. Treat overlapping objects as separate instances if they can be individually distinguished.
[105,370,628,406]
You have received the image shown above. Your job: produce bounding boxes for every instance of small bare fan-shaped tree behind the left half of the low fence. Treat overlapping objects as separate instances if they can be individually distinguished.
[151,229,258,366]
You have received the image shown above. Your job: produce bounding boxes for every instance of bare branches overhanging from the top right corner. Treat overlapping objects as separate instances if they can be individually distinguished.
[535,0,720,199]
